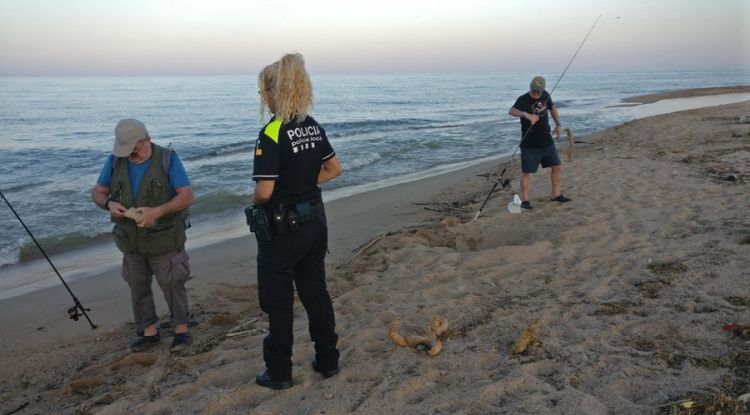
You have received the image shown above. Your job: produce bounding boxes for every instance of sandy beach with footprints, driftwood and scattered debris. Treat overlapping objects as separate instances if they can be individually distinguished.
[0,89,750,415]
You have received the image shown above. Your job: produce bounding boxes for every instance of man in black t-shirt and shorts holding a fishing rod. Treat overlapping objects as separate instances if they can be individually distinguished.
[508,76,571,209]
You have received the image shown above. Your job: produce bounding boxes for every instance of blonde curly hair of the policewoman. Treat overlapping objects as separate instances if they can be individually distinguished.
[258,53,313,123]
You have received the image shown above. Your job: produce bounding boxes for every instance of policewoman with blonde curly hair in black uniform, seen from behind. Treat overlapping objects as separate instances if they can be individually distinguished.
[253,53,341,389]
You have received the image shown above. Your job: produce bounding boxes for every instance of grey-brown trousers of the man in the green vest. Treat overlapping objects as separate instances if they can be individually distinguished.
[122,250,190,333]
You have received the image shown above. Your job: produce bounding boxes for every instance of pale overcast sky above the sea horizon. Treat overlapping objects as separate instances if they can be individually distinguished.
[0,0,750,76]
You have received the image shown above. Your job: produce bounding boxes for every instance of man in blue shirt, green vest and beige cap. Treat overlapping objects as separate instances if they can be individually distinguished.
[91,119,195,352]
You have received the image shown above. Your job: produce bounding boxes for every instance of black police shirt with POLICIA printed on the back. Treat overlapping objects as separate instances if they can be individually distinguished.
[253,116,336,205]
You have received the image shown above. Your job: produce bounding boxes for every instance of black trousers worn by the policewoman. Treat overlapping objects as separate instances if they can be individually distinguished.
[258,214,339,380]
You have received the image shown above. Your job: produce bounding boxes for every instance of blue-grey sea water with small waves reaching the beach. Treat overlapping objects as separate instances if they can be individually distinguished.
[0,71,750,272]
